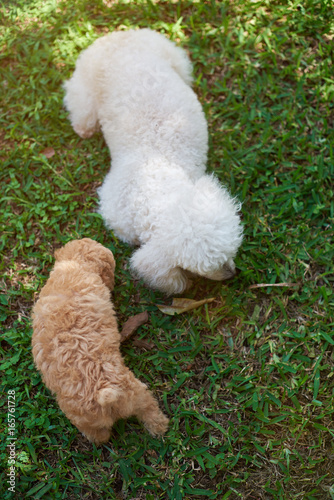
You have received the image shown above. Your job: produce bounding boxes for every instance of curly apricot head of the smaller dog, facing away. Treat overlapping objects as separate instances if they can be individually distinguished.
[55,238,115,290]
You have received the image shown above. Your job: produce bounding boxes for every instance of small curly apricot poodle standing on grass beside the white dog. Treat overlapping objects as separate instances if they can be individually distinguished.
[32,238,168,444]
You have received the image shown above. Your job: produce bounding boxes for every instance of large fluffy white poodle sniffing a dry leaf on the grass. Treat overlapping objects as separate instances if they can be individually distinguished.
[64,29,242,294]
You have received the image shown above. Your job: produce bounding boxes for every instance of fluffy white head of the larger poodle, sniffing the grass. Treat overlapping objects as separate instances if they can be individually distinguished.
[131,175,242,295]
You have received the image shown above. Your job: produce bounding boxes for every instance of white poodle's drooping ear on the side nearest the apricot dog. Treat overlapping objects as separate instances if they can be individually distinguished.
[131,243,189,295]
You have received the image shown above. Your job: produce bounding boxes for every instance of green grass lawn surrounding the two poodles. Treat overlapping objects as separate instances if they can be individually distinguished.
[0,0,334,500]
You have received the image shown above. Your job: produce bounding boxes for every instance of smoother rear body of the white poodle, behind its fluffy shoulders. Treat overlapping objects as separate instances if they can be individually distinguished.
[65,29,208,175]
